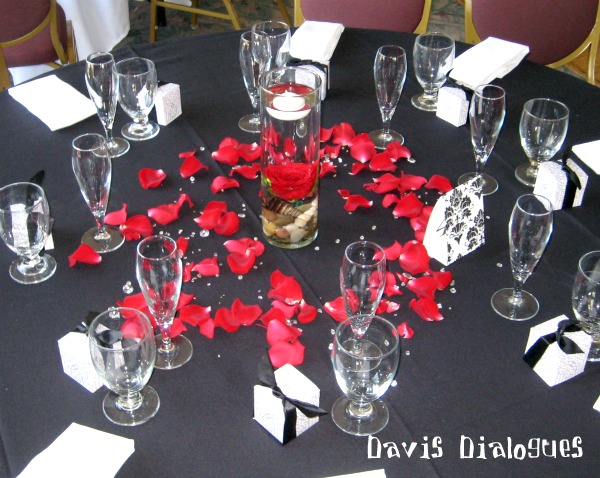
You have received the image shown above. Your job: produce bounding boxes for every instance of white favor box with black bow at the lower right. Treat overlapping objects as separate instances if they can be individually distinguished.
[525,315,592,387]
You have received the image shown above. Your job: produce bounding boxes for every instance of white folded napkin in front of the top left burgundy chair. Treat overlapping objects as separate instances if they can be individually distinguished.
[8,75,96,131]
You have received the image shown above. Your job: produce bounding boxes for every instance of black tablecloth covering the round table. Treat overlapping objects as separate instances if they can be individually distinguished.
[0,29,600,477]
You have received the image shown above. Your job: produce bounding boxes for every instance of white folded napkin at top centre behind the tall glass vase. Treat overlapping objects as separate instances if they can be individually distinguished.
[290,21,344,63]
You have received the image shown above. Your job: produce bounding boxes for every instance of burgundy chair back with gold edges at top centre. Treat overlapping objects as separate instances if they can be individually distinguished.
[294,0,431,33]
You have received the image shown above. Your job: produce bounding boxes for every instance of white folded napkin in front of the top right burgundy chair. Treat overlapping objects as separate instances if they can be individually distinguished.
[450,37,529,90]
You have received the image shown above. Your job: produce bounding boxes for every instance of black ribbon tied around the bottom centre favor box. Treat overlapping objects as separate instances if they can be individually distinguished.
[258,355,327,443]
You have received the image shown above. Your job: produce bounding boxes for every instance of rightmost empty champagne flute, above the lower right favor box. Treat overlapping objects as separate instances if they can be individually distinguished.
[492,194,552,320]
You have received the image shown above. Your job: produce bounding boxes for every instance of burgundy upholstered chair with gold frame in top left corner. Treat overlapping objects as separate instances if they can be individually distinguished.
[0,0,77,90]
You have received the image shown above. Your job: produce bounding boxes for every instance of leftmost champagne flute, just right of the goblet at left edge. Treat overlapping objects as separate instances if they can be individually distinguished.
[71,133,125,254]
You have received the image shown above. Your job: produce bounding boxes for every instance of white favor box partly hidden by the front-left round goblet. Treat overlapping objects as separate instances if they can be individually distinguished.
[58,332,103,393]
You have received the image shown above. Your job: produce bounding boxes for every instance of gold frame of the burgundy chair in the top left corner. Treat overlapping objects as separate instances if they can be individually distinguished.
[0,0,77,90]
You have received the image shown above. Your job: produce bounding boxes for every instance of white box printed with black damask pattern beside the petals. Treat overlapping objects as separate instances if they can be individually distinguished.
[423,178,485,266]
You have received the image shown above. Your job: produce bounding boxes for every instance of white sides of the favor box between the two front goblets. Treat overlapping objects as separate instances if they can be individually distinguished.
[254,364,320,445]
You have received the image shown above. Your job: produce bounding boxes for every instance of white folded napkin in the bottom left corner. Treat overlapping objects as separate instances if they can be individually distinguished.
[18,423,135,478]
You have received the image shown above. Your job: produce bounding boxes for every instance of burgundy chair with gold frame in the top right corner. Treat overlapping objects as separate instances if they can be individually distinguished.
[465,0,600,84]
